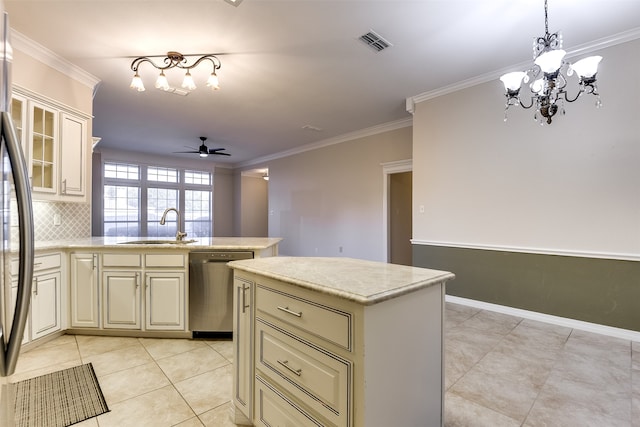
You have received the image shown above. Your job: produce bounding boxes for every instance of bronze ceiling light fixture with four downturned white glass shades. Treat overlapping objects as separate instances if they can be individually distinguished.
[129,51,222,92]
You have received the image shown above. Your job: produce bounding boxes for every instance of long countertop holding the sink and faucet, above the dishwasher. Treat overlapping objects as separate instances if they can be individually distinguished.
[35,236,282,250]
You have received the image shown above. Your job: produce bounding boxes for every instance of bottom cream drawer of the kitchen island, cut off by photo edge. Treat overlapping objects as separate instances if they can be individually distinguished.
[255,376,325,427]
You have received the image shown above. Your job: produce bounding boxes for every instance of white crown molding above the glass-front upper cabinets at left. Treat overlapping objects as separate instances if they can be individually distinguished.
[11,29,100,89]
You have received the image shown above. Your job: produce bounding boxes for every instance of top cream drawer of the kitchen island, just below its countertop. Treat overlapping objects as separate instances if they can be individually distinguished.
[256,285,351,350]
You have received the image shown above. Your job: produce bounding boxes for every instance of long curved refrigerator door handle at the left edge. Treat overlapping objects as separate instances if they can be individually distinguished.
[0,111,34,376]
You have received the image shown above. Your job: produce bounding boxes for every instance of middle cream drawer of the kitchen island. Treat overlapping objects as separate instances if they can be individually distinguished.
[256,320,351,426]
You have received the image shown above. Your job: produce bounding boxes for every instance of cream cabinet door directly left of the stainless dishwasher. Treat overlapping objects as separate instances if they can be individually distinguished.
[145,272,185,330]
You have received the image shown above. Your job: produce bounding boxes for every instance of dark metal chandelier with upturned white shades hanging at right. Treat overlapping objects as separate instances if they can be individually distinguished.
[500,0,602,125]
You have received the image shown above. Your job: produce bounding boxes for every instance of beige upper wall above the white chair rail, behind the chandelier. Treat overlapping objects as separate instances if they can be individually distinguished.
[413,40,640,257]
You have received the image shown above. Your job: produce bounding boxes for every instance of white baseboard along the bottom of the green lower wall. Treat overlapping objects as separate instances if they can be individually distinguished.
[445,295,640,342]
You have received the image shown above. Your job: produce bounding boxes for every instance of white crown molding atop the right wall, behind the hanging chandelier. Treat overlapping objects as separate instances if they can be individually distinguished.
[406,27,640,114]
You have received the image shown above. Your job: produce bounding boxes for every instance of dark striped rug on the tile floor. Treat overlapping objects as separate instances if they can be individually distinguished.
[15,363,109,427]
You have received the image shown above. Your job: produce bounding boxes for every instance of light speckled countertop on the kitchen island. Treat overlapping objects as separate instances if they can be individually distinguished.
[229,257,455,305]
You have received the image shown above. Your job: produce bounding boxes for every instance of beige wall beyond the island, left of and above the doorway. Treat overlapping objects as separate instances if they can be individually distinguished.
[264,127,412,261]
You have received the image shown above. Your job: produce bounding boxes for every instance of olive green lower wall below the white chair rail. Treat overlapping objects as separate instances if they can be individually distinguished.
[413,245,640,331]
